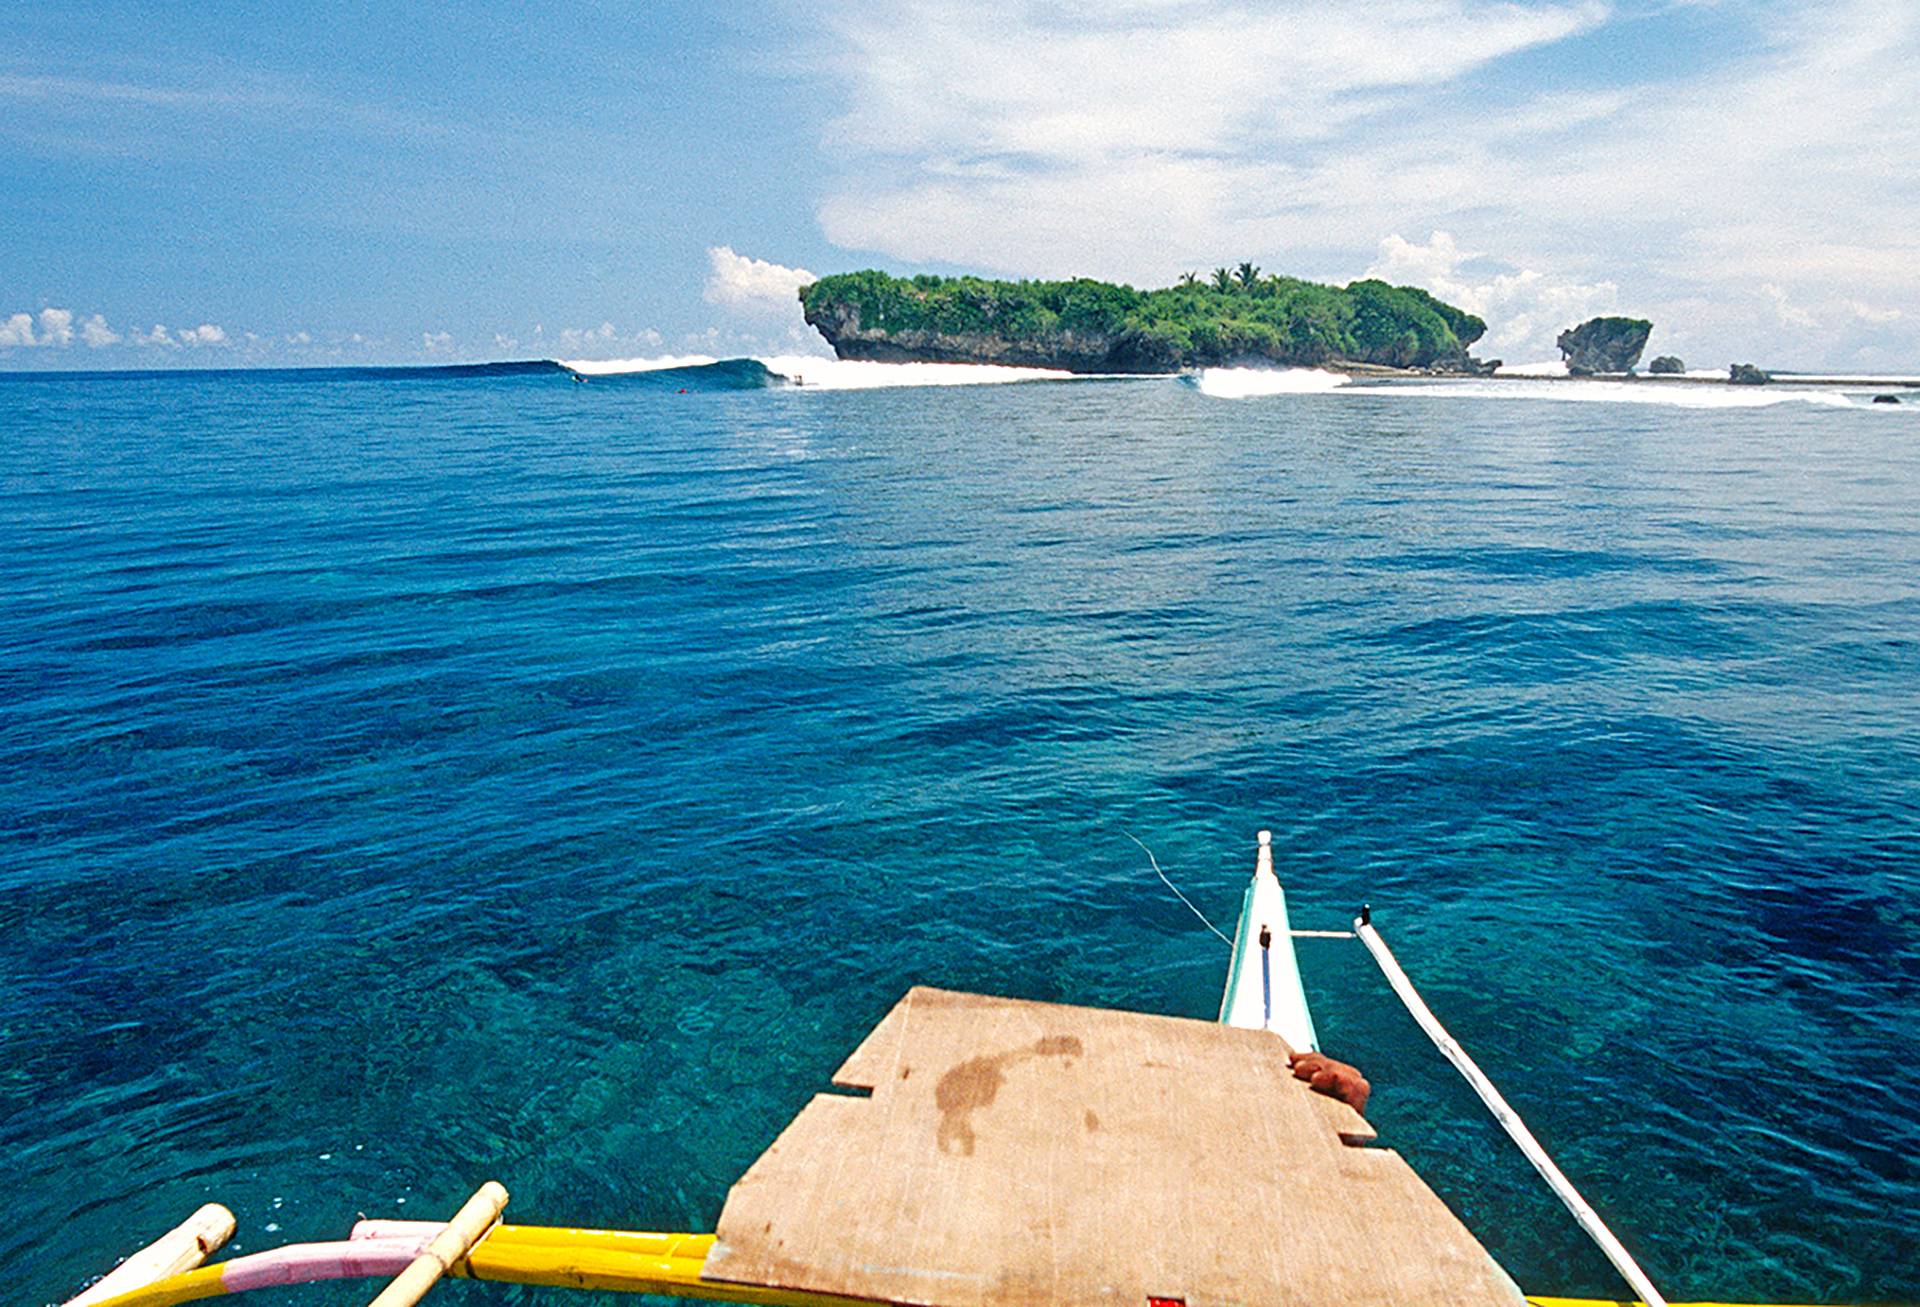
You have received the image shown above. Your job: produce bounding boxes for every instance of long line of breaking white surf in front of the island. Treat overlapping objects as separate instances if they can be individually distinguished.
[555,355,1920,415]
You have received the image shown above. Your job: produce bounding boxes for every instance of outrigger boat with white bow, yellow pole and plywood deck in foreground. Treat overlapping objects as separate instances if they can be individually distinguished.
[67,831,1850,1307]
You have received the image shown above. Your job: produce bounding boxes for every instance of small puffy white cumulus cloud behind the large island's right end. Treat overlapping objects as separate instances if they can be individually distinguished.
[1367,232,1620,361]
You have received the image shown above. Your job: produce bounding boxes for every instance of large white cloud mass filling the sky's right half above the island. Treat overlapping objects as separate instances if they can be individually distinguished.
[816,0,1920,363]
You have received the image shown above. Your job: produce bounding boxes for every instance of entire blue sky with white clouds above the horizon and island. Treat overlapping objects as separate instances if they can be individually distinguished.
[0,0,1920,372]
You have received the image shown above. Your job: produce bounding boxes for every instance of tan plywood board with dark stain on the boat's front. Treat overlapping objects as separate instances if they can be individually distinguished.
[705,988,1523,1307]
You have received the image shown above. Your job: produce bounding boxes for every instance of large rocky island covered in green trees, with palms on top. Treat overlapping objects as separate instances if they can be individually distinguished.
[801,263,1498,376]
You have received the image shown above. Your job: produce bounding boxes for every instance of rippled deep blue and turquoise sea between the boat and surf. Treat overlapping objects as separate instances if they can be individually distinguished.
[0,368,1920,1303]
